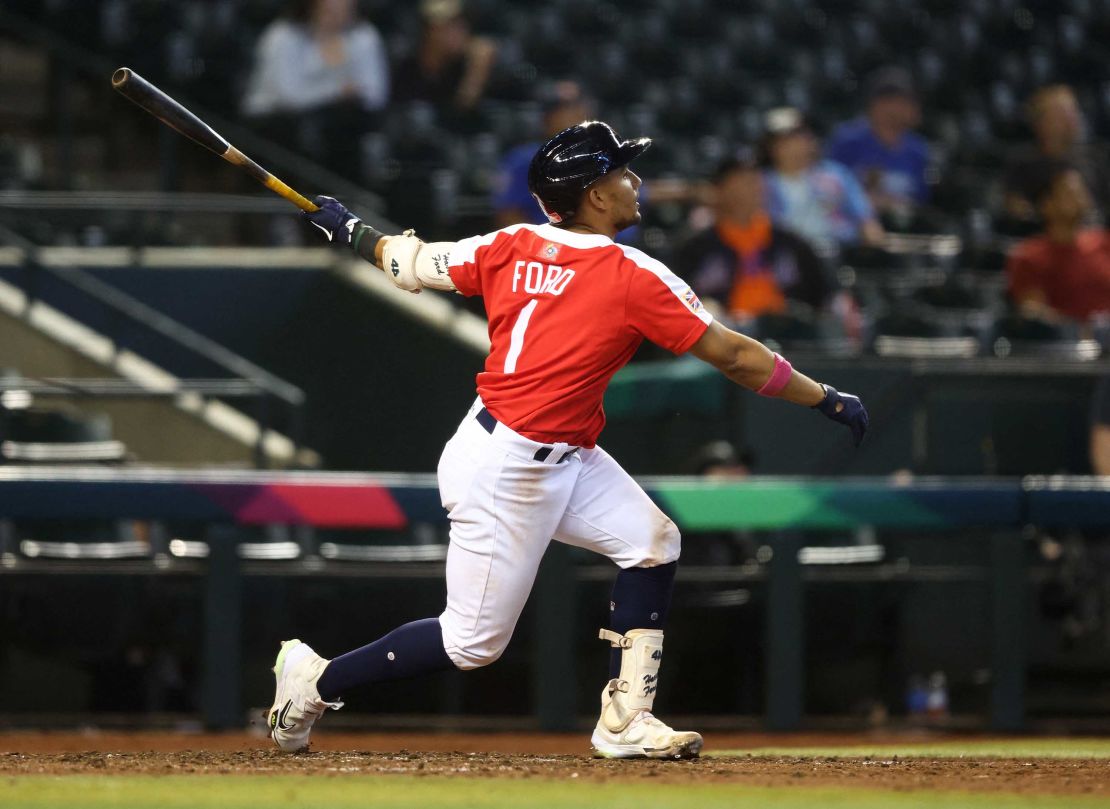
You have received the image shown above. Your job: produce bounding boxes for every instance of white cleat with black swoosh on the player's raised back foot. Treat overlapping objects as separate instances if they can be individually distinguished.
[270,638,343,752]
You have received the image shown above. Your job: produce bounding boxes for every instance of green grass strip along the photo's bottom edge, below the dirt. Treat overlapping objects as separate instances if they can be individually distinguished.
[0,775,1107,809]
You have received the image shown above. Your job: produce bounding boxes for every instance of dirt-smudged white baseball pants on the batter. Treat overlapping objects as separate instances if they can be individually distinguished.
[438,400,679,669]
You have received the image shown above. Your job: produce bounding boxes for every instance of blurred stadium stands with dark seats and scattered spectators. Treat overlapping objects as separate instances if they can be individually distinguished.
[0,0,1110,344]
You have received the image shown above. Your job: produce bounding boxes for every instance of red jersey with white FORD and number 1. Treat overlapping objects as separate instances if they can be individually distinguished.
[450,224,713,447]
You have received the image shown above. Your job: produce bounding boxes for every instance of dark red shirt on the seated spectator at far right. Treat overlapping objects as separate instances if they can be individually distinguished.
[1006,230,1110,321]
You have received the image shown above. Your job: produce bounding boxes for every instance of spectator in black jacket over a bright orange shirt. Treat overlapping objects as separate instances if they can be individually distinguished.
[678,156,831,320]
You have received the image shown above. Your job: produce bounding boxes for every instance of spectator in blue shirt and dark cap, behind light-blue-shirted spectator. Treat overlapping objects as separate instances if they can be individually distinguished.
[826,68,929,214]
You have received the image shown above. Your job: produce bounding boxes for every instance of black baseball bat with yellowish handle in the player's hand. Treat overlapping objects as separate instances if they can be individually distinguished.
[112,68,320,212]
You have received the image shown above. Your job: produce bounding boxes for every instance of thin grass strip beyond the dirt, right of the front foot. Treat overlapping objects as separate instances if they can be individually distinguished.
[708,738,1110,759]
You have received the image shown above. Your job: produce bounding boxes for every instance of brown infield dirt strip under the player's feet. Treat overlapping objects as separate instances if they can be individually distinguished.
[0,732,1110,796]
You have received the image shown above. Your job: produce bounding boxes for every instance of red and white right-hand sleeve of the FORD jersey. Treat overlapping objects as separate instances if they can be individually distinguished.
[625,249,713,354]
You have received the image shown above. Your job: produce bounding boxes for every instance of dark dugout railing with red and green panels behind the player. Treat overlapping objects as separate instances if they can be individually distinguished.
[0,467,1110,730]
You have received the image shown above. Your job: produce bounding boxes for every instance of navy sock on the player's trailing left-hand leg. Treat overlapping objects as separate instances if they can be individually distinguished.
[316,618,455,702]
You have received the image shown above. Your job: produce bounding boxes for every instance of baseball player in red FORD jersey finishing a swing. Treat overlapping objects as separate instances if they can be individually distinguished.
[270,121,867,758]
